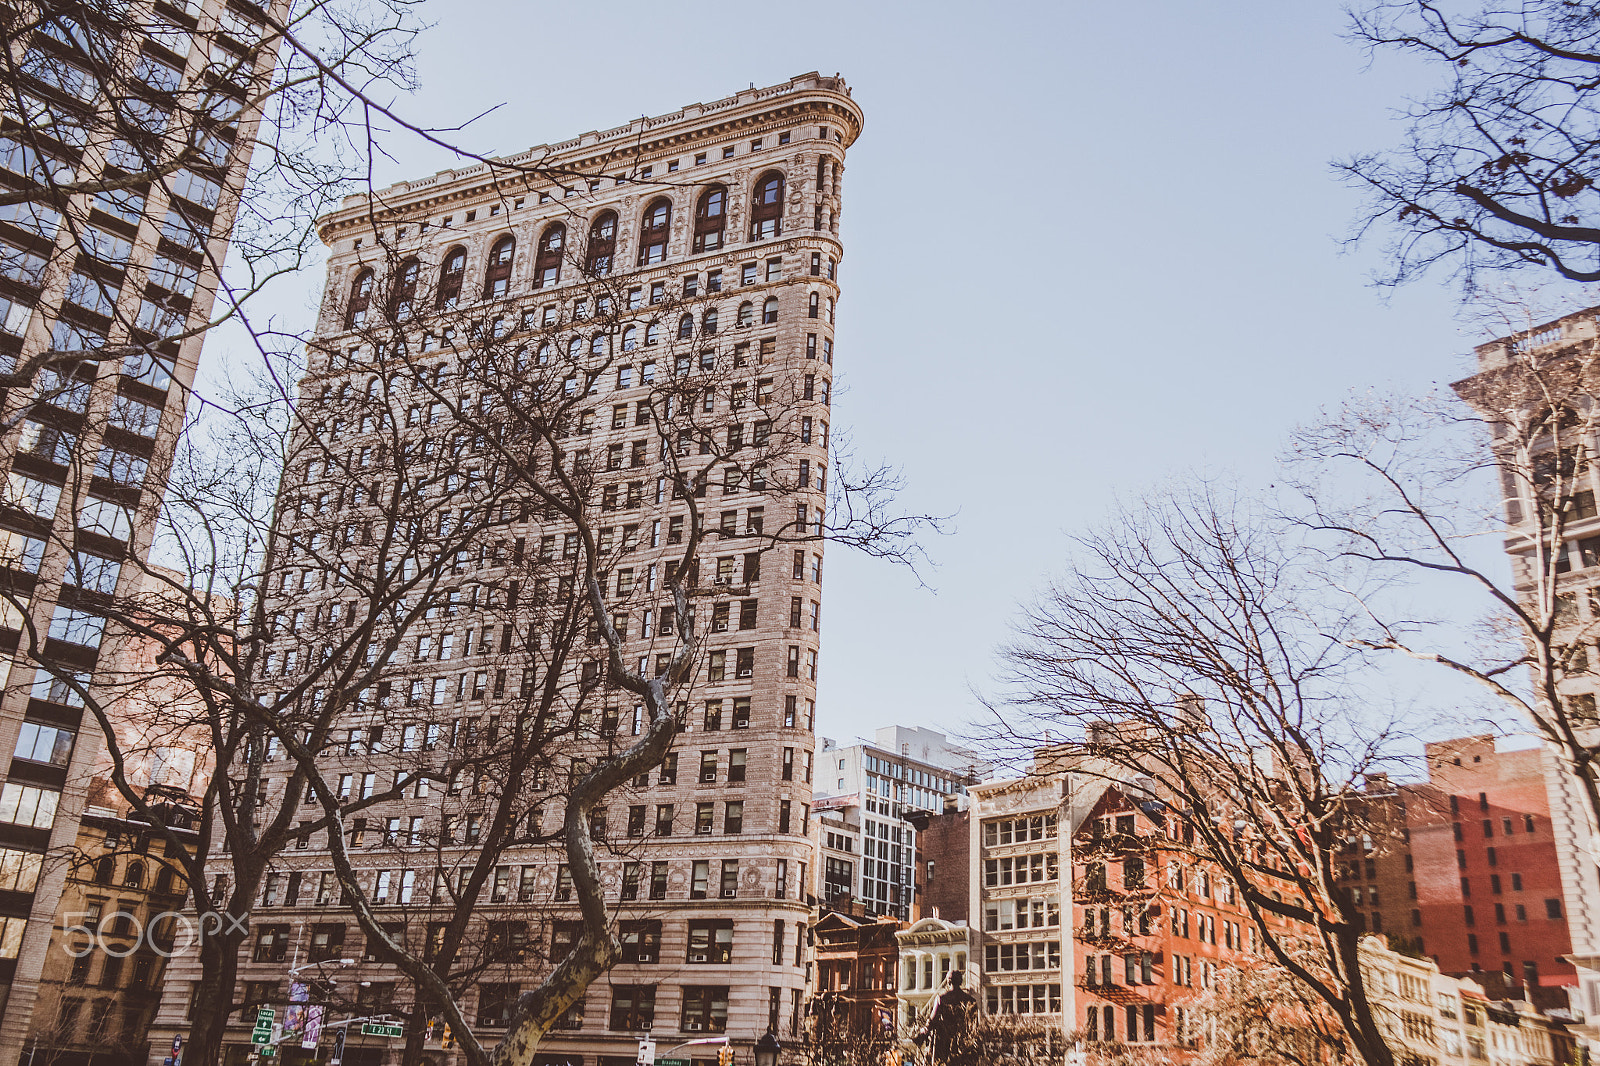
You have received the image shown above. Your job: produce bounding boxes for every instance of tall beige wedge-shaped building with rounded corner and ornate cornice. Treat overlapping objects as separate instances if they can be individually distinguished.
[152,74,862,1066]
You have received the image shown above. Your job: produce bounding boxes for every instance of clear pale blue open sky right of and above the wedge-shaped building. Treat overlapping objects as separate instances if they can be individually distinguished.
[218,0,1510,743]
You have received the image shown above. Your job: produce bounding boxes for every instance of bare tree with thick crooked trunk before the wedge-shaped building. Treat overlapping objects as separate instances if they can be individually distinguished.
[283,240,926,1063]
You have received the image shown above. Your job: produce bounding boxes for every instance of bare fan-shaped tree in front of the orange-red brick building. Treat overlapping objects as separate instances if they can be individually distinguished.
[1006,485,1397,1066]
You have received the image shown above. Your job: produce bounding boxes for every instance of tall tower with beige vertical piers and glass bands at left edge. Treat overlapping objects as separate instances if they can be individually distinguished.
[0,0,277,1066]
